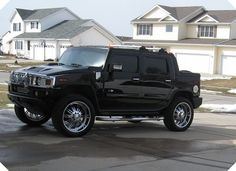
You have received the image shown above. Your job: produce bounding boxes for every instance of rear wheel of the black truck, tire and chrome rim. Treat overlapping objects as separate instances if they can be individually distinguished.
[164,97,194,132]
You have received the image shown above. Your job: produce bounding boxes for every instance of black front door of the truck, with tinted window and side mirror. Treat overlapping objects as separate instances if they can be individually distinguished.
[99,51,141,112]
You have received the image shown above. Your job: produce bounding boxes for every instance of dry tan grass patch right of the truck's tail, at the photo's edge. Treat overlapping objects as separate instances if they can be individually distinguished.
[201,78,236,95]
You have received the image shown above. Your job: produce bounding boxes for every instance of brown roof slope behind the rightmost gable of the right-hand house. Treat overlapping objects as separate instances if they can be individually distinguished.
[189,10,236,23]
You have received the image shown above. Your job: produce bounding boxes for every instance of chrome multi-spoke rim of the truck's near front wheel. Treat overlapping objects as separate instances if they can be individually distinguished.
[62,101,91,133]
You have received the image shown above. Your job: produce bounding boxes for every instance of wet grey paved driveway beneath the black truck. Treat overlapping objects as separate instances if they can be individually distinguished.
[0,110,236,171]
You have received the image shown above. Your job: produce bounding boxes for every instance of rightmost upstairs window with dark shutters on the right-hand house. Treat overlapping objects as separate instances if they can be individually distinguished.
[198,26,217,37]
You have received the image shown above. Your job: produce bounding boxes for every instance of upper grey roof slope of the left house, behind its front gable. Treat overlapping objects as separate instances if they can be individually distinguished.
[16,8,65,20]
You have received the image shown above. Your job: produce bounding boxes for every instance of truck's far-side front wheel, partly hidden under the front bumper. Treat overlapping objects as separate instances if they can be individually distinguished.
[14,105,51,127]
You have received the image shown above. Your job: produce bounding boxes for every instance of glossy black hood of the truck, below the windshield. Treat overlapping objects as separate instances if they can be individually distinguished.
[16,64,89,76]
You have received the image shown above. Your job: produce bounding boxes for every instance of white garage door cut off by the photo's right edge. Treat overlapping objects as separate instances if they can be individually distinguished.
[222,56,236,76]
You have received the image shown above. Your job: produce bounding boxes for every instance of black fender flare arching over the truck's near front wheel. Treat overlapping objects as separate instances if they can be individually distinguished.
[63,85,99,113]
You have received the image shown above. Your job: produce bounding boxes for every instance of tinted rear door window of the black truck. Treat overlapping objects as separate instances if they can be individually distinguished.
[144,56,168,74]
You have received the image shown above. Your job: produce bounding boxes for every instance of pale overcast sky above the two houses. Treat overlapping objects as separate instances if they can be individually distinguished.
[0,0,236,37]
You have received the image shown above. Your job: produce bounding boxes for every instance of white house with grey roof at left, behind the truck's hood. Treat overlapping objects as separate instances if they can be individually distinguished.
[2,8,121,60]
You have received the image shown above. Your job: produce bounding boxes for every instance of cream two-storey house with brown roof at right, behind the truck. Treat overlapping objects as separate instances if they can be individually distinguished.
[124,5,236,76]
